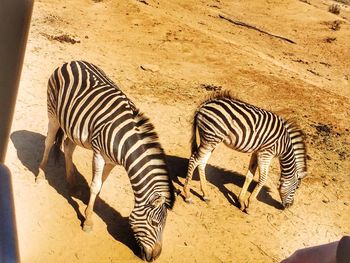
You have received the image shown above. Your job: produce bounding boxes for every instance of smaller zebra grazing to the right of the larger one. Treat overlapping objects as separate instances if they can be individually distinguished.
[183,92,307,212]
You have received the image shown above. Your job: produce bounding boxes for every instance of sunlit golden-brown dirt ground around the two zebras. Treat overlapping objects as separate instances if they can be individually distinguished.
[7,0,350,263]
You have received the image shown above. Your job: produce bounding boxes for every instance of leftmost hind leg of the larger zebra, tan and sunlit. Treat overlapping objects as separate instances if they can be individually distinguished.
[35,115,60,184]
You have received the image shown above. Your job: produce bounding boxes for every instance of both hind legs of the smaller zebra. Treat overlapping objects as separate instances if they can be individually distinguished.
[184,146,211,203]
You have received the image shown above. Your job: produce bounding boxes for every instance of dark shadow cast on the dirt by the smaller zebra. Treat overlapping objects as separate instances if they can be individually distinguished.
[166,155,283,210]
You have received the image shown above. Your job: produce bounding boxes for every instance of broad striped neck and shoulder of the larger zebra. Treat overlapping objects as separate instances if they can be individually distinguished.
[114,114,174,207]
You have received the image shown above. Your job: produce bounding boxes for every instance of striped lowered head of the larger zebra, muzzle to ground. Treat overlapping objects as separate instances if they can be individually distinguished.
[129,193,167,261]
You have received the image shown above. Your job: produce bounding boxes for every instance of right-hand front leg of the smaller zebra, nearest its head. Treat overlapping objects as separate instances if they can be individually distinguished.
[246,153,273,213]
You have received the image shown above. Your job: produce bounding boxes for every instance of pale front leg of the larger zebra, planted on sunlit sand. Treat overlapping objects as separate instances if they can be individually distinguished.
[83,153,105,232]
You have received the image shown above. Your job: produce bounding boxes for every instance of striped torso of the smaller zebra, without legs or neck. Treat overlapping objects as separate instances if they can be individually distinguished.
[195,93,286,152]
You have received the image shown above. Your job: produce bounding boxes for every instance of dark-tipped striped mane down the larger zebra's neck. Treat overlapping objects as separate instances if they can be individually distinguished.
[134,109,175,209]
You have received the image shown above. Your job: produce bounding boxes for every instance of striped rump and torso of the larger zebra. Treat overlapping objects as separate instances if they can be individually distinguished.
[48,61,138,148]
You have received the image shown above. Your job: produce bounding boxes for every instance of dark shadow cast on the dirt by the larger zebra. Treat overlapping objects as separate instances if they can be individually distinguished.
[11,130,140,256]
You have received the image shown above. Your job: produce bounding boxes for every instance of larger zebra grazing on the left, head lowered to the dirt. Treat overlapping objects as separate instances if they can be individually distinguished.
[36,61,175,261]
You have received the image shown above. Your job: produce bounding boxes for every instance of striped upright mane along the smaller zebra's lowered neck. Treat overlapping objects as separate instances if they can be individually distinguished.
[285,120,307,179]
